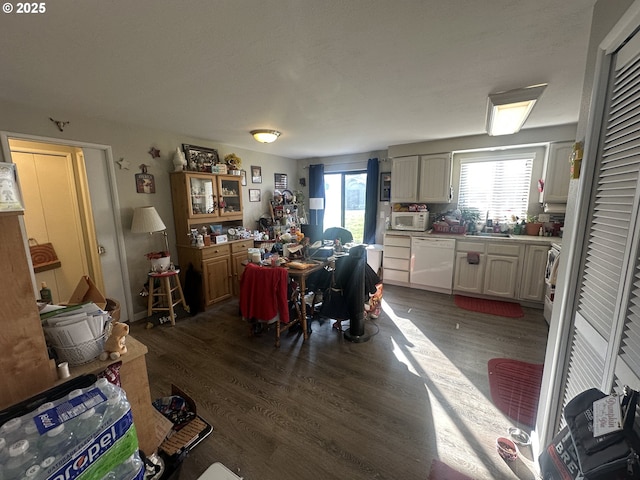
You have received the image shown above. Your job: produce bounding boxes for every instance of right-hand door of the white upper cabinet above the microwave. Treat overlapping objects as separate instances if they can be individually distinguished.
[418,153,453,203]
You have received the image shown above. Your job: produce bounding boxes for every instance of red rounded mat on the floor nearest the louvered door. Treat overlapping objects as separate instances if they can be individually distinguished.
[488,358,543,427]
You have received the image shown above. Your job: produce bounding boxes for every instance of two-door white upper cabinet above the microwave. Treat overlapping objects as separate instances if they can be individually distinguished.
[391,153,452,203]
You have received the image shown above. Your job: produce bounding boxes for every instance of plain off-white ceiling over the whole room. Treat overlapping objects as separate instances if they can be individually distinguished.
[0,0,595,159]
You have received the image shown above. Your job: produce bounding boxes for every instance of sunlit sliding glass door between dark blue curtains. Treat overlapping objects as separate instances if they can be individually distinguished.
[324,171,367,243]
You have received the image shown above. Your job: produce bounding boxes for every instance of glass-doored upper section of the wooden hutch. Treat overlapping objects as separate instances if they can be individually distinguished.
[170,172,242,239]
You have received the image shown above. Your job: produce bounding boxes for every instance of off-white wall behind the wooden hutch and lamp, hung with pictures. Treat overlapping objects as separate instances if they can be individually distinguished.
[0,97,298,313]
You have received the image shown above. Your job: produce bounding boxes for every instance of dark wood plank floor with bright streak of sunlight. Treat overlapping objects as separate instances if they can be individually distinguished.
[131,285,548,480]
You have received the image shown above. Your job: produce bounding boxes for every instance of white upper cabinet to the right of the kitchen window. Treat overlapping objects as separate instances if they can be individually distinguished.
[540,142,573,203]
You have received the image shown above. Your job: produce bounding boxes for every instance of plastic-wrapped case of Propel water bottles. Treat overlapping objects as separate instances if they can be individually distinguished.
[0,377,144,480]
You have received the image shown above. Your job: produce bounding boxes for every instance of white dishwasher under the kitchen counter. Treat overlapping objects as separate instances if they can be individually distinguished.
[409,237,456,293]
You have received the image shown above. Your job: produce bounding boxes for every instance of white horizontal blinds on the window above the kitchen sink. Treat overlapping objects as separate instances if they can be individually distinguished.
[458,152,535,221]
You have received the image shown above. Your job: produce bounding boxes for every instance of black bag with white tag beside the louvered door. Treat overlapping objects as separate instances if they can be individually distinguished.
[564,386,640,480]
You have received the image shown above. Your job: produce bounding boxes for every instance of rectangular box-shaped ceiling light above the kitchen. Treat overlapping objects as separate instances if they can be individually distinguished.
[487,83,547,136]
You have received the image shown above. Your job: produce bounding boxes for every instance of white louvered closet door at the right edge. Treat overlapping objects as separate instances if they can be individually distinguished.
[563,29,640,428]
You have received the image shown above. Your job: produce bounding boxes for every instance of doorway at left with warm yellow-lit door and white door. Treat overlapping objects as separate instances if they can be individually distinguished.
[0,132,133,321]
